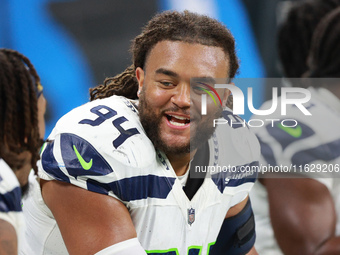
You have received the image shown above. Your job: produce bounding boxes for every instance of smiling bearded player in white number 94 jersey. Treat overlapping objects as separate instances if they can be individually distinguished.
[22,12,259,255]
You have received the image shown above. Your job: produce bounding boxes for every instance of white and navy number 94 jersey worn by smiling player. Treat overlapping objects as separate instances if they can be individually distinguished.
[22,96,260,255]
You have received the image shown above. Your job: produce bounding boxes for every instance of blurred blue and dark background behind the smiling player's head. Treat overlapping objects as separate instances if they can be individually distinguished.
[0,0,298,136]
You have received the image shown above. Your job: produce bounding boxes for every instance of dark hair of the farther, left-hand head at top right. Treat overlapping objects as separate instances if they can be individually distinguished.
[277,0,340,81]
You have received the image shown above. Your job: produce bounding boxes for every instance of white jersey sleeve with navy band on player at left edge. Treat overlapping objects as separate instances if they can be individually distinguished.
[0,158,25,247]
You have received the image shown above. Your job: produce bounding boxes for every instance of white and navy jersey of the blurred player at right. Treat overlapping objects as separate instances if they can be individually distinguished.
[250,88,340,255]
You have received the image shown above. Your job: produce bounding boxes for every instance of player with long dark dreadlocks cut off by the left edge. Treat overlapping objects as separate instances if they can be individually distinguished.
[0,49,46,254]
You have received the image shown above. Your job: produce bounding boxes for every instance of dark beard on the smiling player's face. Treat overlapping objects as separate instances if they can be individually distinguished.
[138,92,222,154]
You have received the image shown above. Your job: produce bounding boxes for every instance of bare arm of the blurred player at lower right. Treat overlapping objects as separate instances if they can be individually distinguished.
[262,178,340,255]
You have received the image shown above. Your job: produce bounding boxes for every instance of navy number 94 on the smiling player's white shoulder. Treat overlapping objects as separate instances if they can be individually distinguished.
[79,105,139,149]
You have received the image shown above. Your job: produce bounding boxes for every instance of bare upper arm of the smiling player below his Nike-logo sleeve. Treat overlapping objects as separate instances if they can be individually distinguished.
[41,180,146,255]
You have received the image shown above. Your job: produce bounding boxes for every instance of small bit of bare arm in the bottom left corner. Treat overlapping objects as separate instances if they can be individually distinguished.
[0,219,18,255]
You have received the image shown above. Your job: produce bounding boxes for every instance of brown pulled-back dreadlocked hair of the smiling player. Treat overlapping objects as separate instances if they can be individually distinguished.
[90,11,239,108]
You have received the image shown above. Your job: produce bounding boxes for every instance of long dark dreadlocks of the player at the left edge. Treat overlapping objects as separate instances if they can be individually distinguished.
[0,49,42,172]
